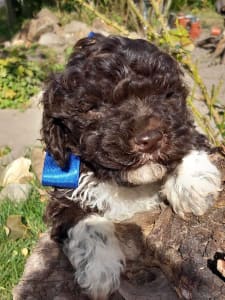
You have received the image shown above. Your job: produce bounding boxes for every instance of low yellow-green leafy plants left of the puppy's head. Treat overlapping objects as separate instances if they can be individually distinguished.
[0,45,62,109]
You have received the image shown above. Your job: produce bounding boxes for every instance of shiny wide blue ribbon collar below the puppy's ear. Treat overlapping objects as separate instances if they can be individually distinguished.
[42,152,80,189]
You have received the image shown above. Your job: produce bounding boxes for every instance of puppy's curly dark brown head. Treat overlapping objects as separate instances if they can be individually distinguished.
[42,34,207,183]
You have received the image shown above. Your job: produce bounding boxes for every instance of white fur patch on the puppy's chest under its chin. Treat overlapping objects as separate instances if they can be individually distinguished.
[69,172,160,221]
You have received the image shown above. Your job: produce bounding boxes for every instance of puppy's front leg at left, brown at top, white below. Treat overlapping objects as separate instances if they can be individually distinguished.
[45,198,125,300]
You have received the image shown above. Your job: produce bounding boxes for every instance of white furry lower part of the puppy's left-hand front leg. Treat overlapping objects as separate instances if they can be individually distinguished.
[64,215,125,299]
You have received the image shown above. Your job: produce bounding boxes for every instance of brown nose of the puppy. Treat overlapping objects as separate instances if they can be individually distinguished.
[134,130,163,152]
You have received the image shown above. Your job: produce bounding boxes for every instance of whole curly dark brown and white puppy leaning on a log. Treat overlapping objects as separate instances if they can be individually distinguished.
[42,34,221,299]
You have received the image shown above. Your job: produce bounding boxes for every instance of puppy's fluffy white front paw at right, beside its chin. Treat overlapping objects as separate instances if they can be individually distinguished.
[162,151,221,217]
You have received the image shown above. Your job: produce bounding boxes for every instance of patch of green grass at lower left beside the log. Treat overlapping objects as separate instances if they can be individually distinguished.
[0,189,45,300]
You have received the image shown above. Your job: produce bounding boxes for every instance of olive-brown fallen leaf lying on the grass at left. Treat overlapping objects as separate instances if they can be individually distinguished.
[6,215,28,240]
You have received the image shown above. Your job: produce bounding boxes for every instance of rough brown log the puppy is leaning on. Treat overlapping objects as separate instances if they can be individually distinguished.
[13,156,225,300]
